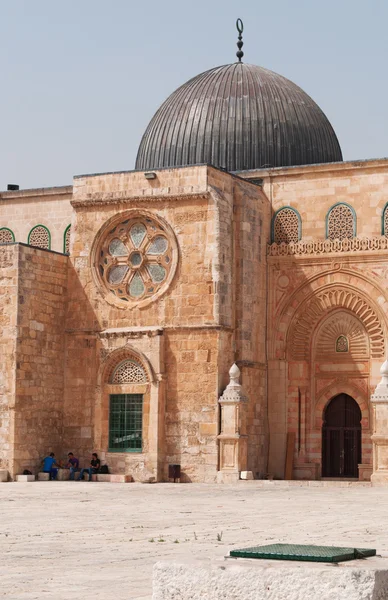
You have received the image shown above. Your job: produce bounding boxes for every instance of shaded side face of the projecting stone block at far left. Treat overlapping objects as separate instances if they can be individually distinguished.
[10,245,68,475]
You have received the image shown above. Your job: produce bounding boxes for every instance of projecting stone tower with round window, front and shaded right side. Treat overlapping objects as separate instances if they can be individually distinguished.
[65,167,269,481]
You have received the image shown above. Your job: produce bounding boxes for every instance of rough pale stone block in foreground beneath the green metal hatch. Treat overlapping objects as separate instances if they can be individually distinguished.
[152,557,388,600]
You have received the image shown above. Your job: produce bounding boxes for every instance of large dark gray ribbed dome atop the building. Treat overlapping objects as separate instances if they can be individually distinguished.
[136,62,342,171]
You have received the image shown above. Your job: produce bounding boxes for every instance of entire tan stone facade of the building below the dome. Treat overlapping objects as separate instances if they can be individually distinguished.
[0,160,388,482]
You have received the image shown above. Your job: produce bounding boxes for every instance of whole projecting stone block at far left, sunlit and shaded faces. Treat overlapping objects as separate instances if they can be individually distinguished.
[0,244,68,478]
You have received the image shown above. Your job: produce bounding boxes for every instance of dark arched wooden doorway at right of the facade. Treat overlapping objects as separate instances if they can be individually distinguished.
[322,394,361,478]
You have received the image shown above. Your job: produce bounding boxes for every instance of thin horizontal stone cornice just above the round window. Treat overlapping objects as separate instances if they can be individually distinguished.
[71,195,210,208]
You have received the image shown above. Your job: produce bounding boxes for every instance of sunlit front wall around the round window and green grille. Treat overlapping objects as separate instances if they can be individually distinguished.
[64,167,223,481]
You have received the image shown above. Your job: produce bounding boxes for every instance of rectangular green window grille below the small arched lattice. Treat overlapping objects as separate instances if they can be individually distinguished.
[109,394,143,452]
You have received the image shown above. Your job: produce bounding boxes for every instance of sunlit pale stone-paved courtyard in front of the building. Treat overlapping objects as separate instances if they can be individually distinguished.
[0,482,388,600]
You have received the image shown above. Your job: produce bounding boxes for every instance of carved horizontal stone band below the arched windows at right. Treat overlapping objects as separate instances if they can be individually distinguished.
[267,236,388,256]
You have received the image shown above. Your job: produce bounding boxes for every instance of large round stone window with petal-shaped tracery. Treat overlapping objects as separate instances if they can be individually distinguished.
[96,214,178,307]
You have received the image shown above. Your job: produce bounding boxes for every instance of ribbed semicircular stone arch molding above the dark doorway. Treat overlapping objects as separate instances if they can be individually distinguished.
[289,288,385,360]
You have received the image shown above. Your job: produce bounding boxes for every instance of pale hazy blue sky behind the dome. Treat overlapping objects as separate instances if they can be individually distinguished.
[0,0,388,190]
